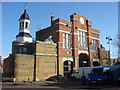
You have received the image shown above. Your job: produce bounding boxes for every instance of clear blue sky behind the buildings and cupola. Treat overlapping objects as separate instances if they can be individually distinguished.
[2,2,118,57]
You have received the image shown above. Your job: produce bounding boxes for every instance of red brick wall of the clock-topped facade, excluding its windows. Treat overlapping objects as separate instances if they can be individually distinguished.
[37,14,100,62]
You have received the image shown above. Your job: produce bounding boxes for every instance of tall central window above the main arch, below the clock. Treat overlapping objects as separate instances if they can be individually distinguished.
[78,31,87,47]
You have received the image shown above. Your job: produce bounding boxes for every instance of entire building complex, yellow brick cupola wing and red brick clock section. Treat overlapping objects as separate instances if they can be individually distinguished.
[3,10,100,81]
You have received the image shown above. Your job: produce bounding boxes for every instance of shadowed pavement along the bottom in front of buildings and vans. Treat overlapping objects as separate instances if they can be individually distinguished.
[0,79,120,90]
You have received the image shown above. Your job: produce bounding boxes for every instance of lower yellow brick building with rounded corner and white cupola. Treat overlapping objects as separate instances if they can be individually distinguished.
[3,10,58,81]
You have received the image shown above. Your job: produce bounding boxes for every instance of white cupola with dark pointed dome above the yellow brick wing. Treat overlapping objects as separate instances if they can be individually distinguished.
[16,9,32,42]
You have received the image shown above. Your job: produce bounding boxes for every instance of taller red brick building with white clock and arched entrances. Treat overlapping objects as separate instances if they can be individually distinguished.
[36,13,100,73]
